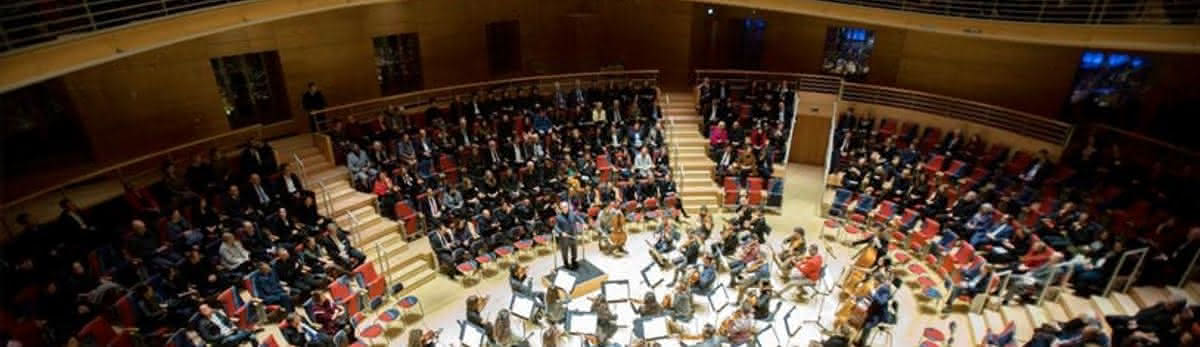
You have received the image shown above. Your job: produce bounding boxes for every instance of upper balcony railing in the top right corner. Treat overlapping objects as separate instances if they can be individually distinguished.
[821,0,1200,24]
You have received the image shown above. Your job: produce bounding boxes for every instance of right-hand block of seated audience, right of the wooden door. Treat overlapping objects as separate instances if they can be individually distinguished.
[824,109,1200,346]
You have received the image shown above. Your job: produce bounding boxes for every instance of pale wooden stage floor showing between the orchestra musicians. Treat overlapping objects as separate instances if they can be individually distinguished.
[388,164,966,346]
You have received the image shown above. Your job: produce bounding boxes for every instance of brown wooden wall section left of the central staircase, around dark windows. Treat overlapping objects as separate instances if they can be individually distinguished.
[56,0,691,163]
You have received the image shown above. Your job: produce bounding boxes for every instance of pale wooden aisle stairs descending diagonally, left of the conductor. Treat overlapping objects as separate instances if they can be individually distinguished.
[271,133,437,294]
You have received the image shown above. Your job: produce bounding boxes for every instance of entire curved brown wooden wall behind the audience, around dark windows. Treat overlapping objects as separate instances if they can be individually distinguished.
[0,0,1200,202]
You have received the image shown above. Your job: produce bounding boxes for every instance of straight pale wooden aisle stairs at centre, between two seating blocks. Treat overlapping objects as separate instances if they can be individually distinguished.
[662,91,720,214]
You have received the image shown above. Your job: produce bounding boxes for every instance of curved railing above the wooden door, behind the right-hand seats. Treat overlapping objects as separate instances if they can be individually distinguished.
[696,70,1074,146]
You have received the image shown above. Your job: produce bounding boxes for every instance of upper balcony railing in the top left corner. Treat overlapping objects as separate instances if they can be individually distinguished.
[0,0,254,52]
